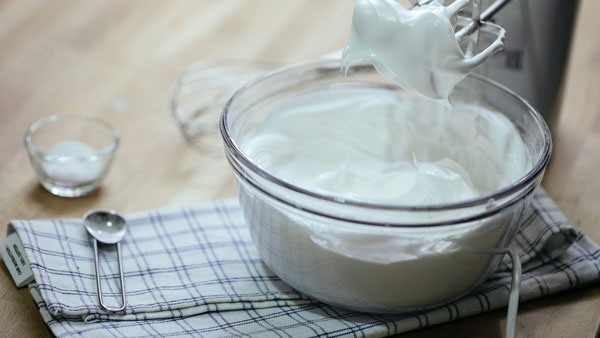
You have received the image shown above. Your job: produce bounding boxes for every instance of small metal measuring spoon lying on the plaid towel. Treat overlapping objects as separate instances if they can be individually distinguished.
[83,210,127,312]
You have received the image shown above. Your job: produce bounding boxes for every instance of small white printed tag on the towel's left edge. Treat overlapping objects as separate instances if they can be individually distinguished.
[0,232,33,288]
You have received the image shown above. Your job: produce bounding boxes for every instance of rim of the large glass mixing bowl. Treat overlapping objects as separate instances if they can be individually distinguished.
[219,59,552,212]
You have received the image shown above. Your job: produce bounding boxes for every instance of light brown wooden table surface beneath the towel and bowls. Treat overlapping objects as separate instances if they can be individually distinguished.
[0,0,600,337]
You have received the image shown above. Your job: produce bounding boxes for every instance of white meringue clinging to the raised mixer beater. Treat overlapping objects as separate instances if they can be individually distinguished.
[342,0,504,103]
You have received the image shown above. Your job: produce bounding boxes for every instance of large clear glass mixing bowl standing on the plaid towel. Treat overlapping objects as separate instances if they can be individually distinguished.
[220,60,552,312]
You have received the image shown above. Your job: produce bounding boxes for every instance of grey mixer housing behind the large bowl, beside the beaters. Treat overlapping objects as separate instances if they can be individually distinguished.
[476,0,579,129]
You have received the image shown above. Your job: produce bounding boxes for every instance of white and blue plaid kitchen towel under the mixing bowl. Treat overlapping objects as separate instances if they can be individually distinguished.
[4,189,600,337]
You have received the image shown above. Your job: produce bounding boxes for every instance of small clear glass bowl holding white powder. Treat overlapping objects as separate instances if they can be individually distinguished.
[25,115,119,197]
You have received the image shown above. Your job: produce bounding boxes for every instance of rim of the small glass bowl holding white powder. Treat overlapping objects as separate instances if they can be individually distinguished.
[24,114,121,162]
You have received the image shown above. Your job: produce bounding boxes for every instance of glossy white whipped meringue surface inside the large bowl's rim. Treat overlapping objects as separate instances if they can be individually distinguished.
[240,88,528,205]
